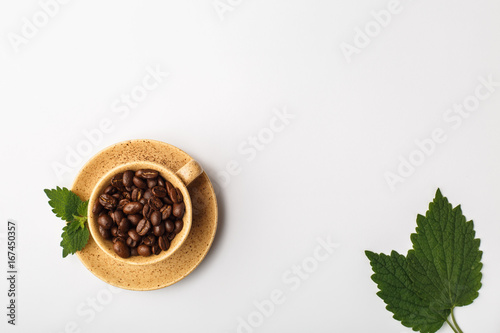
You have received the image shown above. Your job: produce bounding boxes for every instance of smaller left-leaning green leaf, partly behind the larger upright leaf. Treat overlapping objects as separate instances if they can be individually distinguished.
[365,251,450,333]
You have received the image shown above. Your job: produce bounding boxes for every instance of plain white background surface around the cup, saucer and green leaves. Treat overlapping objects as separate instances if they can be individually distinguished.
[0,0,500,333]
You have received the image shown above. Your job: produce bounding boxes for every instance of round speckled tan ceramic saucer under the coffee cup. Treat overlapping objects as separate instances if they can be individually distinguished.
[72,140,217,290]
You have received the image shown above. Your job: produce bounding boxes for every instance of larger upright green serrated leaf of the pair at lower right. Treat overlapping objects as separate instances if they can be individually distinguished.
[408,190,483,310]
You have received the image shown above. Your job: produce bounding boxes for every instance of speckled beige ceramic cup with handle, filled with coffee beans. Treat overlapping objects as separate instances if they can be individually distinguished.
[88,160,203,265]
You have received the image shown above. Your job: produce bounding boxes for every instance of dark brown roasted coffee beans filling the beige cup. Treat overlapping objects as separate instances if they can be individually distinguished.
[92,169,185,258]
